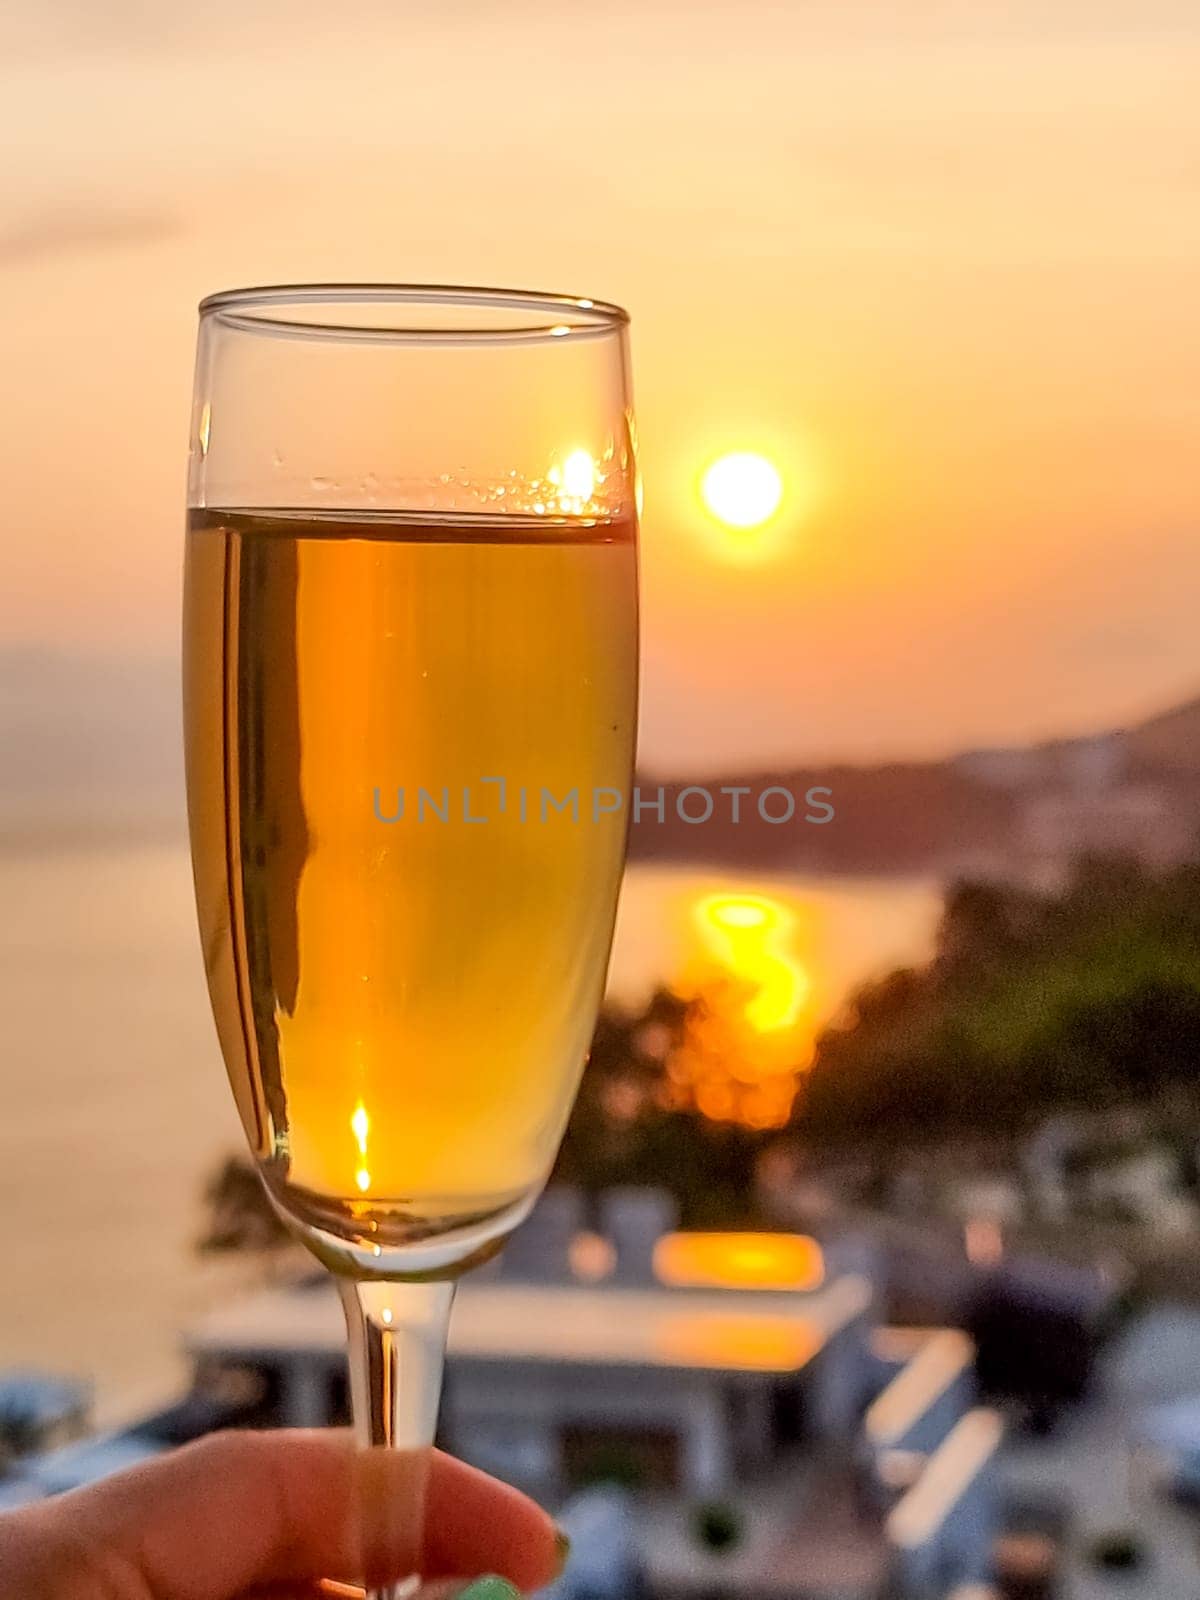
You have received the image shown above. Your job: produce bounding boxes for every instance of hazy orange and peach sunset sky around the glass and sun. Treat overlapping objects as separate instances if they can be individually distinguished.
[0,0,1200,771]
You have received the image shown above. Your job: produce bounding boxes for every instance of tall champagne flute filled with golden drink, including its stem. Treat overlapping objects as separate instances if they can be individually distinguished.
[184,285,637,1597]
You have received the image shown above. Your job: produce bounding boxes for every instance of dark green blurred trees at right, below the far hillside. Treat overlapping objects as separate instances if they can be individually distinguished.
[802,859,1200,1139]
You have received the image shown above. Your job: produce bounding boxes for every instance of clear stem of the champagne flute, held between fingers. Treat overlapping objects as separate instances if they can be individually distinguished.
[338,1278,454,1600]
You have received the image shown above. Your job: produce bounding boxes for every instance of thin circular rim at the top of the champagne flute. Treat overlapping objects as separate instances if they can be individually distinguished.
[200,283,629,344]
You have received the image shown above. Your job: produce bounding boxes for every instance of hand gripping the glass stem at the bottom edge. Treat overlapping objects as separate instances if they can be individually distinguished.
[0,1429,563,1600]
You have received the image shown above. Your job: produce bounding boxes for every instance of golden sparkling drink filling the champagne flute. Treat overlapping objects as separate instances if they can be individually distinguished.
[184,510,637,1245]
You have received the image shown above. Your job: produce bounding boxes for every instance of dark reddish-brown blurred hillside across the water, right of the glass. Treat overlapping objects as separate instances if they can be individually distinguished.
[630,699,1200,882]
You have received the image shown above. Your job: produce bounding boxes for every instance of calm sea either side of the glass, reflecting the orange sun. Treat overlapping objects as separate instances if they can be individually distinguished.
[0,838,941,1424]
